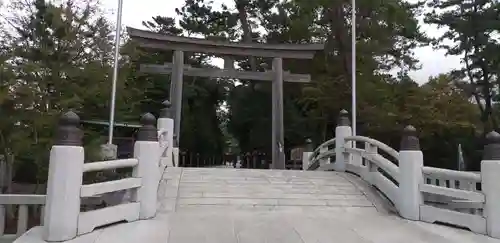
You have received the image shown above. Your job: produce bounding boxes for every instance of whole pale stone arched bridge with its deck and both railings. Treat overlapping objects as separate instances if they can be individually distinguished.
[0,112,500,243]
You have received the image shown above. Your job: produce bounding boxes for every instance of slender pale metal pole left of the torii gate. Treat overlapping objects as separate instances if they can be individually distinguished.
[108,0,123,144]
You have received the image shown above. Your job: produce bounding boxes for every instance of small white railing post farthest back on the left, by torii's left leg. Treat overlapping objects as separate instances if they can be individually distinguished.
[157,100,174,168]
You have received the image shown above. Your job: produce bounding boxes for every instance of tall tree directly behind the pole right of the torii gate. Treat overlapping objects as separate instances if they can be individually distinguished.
[293,0,427,136]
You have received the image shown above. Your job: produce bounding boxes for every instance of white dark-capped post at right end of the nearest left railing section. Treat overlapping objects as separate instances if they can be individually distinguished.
[134,113,160,219]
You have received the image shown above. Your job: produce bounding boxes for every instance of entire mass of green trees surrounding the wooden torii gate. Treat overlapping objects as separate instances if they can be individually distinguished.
[0,0,492,185]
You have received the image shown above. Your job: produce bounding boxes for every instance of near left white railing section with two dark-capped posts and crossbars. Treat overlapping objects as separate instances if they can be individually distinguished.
[39,112,165,241]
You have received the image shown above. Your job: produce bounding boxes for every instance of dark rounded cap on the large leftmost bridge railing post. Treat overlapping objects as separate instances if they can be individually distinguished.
[54,111,83,146]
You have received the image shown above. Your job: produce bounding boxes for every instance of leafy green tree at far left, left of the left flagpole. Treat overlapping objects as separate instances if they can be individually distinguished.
[1,0,122,183]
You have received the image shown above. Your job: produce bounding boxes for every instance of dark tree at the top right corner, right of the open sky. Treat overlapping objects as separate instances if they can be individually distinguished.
[425,0,500,134]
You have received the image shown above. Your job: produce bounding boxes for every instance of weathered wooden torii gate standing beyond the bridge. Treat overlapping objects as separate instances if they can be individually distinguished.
[127,27,324,169]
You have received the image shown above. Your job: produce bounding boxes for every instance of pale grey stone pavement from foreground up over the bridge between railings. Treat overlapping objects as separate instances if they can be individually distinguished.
[14,168,500,243]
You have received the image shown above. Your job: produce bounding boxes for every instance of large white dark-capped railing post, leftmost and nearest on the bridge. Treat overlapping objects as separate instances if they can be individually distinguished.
[43,111,84,242]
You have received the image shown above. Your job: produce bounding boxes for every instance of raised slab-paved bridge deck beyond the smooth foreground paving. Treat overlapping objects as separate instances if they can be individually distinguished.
[160,168,373,212]
